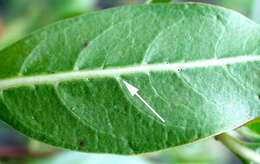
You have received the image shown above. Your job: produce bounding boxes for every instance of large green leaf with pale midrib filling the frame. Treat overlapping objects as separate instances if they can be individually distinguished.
[0,3,260,154]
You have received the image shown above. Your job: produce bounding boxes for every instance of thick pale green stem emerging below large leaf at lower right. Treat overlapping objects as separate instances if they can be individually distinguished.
[215,133,260,163]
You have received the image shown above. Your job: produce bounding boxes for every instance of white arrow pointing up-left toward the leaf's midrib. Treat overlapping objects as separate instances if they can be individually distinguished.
[123,81,165,122]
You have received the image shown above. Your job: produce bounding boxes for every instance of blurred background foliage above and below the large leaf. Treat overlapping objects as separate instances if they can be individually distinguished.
[0,0,260,164]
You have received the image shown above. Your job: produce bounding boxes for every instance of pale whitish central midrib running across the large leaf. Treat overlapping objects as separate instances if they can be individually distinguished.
[0,56,260,90]
